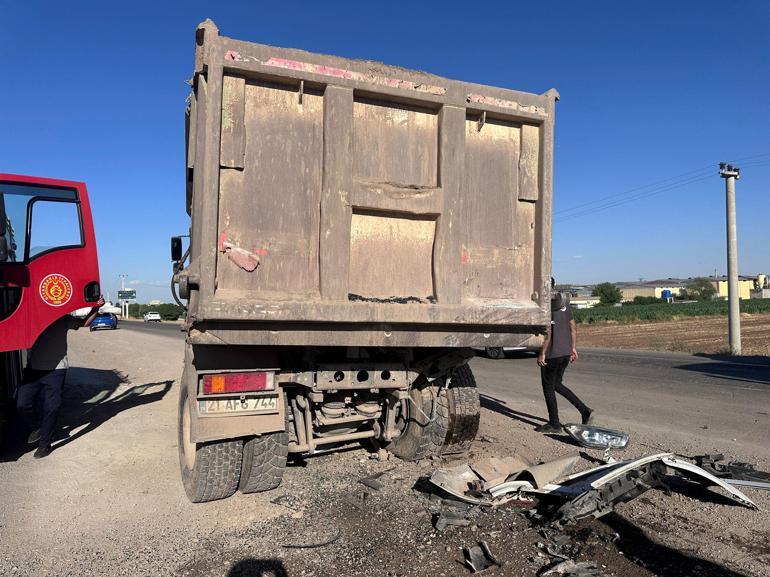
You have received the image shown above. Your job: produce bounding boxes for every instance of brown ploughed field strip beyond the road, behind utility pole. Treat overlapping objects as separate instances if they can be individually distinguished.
[578,314,770,356]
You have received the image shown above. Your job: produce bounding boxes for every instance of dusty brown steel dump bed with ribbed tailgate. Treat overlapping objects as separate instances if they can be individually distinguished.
[187,21,558,347]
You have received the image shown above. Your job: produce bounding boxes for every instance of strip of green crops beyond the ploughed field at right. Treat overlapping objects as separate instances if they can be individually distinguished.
[572,299,770,324]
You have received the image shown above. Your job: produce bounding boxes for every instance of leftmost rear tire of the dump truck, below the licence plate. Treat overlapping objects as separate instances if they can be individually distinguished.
[178,379,243,503]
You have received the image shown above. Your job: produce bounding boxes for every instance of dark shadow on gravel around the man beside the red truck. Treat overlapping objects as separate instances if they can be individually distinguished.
[0,367,173,462]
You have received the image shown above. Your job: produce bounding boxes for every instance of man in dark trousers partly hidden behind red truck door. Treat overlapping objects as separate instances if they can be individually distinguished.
[16,300,104,459]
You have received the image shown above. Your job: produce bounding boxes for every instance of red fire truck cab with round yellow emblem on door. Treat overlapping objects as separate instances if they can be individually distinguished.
[0,174,101,433]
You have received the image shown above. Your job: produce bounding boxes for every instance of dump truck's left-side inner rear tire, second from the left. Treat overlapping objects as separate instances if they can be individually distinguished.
[239,431,289,493]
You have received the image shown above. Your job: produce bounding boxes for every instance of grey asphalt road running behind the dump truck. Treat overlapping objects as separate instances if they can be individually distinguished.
[120,322,770,453]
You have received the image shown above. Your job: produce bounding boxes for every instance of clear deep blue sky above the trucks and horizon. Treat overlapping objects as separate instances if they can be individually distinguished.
[0,0,770,301]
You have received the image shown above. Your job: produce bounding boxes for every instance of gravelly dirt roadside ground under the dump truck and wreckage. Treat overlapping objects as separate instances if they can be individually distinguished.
[0,330,770,577]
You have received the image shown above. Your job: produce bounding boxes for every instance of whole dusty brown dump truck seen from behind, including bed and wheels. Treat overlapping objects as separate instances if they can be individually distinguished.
[172,21,558,501]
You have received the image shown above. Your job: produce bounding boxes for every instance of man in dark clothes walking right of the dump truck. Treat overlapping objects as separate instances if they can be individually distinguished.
[535,279,593,433]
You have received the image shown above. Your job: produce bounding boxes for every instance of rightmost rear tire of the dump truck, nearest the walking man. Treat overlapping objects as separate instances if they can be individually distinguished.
[441,365,481,455]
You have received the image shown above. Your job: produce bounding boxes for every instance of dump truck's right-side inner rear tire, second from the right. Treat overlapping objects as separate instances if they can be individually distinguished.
[387,381,449,461]
